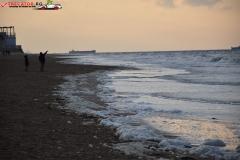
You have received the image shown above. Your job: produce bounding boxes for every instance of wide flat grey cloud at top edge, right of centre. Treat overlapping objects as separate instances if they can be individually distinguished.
[183,0,222,7]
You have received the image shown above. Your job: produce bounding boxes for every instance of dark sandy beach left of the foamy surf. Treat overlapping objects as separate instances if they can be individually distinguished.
[0,54,211,160]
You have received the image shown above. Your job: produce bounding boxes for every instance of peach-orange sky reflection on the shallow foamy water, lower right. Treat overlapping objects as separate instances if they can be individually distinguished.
[144,116,240,150]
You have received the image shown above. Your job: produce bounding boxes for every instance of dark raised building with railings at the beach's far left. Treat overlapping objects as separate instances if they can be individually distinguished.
[0,26,23,53]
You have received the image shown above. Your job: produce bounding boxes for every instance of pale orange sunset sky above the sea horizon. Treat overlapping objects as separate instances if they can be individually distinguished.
[0,0,240,53]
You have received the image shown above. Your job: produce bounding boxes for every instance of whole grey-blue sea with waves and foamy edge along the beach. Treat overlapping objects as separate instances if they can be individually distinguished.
[56,50,240,160]
